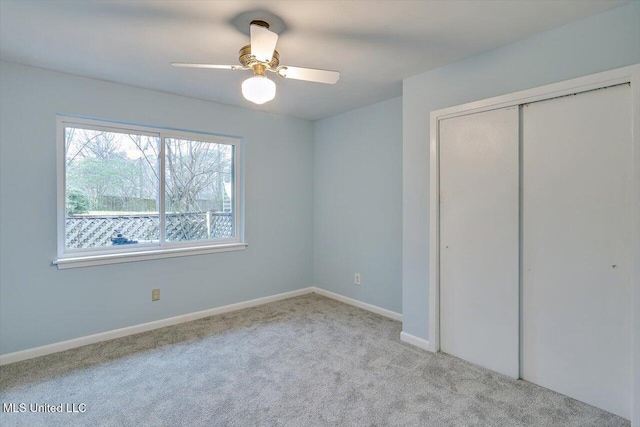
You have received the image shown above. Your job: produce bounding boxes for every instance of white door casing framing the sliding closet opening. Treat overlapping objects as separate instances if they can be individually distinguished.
[429,64,640,427]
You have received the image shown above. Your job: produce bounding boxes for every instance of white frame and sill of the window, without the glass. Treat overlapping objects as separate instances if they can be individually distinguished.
[53,115,247,269]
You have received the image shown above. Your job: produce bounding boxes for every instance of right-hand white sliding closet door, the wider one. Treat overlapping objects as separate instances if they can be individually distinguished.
[522,85,632,418]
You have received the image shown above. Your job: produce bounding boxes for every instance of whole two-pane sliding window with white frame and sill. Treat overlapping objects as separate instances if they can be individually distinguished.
[56,117,246,268]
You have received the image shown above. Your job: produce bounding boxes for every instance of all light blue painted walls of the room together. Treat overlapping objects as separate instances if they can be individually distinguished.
[0,1,640,354]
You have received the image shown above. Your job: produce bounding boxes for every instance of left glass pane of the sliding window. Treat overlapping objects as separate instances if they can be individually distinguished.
[64,127,160,249]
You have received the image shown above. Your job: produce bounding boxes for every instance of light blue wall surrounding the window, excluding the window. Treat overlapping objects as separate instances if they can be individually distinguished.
[0,62,313,354]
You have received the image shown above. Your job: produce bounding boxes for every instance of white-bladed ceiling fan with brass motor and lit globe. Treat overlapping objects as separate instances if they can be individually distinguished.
[171,21,340,104]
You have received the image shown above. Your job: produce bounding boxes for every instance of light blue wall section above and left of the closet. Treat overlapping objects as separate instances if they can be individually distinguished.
[402,2,640,339]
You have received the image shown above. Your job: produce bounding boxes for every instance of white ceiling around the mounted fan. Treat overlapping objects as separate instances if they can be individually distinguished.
[0,0,628,119]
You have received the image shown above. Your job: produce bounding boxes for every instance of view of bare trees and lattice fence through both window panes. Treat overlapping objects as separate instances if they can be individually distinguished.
[64,123,235,249]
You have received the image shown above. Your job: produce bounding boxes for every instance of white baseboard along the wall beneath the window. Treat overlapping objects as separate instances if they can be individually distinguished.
[0,287,314,366]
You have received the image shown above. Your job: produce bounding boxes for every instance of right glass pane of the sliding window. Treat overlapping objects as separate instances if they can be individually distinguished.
[165,138,235,242]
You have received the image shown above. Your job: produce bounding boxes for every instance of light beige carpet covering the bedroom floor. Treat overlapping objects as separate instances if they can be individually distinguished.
[0,294,629,427]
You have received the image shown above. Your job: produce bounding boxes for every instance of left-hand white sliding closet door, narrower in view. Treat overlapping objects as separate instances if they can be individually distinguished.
[439,108,519,378]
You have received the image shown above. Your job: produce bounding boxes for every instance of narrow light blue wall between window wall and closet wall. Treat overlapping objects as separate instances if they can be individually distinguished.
[313,98,402,313]
